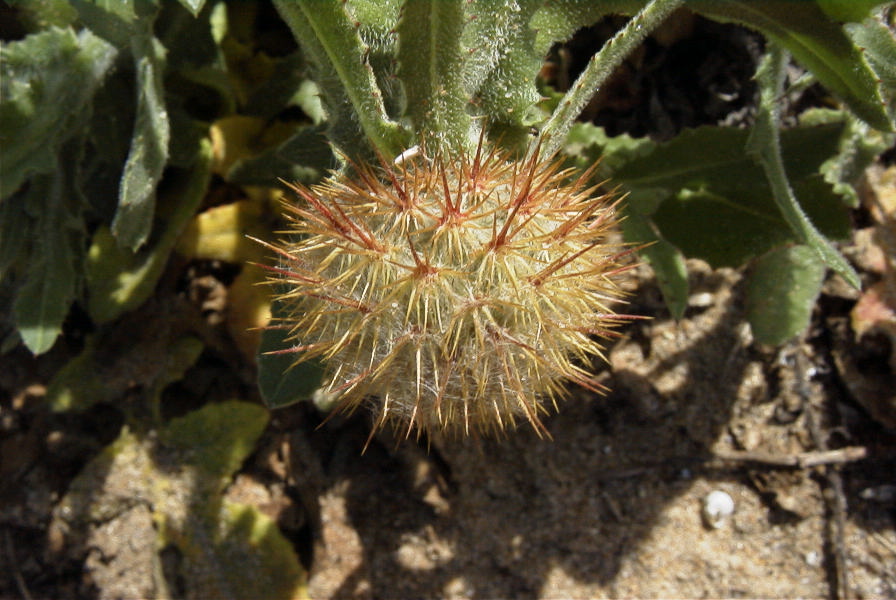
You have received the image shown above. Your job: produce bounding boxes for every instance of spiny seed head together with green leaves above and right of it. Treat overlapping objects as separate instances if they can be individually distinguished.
[263,0,893,431]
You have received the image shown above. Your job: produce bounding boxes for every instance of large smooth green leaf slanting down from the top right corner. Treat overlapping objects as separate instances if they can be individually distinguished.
[688,0,893,131]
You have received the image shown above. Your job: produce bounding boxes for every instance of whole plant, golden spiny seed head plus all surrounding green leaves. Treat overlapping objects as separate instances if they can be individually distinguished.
[0,0,896,597]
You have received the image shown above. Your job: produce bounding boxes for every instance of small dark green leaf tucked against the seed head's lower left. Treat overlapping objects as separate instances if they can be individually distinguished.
[258,301,324,409]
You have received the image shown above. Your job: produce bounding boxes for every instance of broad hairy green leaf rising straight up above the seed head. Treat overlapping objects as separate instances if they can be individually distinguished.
[398,0,475,152]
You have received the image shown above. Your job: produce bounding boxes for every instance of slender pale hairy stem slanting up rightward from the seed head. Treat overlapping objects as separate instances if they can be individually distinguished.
[529,0,684,156]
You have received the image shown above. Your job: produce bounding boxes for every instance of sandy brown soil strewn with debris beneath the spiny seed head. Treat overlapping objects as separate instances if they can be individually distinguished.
[0,9,896,600]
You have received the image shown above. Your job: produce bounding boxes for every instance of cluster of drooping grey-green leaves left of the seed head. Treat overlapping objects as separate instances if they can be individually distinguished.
[0,0,332,354]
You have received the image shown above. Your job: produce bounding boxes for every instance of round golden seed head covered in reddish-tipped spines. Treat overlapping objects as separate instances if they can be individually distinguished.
[273,145,630,434]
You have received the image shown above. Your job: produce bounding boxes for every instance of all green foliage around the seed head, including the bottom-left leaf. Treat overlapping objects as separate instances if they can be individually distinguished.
[0,0,896,597]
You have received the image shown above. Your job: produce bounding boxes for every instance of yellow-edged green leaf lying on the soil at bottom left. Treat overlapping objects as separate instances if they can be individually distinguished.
[157,402,305,600]
